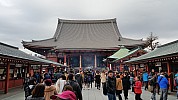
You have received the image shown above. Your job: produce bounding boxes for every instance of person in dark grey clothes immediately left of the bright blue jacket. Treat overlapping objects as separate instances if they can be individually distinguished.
[149,73,157,100]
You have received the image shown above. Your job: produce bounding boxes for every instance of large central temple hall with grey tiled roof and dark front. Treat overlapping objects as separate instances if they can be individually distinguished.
[22,19,145,69]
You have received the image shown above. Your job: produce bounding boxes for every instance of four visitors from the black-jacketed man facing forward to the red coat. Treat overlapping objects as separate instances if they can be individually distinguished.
[103,70,142,100]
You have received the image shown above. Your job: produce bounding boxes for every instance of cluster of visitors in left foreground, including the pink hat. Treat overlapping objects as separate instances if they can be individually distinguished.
[24,72,82,100]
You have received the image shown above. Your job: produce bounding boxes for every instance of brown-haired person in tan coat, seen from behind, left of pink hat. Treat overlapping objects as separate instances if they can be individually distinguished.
[44,79,57,100]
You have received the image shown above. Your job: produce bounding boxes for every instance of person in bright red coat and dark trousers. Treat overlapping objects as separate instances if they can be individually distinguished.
[134,77,142,100]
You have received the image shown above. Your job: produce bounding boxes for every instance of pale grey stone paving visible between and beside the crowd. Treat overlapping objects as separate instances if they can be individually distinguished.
[0,87,178,100]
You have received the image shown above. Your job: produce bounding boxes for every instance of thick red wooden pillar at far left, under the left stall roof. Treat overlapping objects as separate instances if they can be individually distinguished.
[4,62,10,94]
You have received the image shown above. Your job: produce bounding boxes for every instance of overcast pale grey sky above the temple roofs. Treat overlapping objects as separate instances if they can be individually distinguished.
[0,0,178,54]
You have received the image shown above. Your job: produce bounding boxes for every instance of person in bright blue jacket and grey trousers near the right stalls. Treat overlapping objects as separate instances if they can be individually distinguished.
[158,72,169,100]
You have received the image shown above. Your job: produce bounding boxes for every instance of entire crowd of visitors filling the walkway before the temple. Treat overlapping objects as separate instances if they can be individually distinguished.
[24,69,178,100]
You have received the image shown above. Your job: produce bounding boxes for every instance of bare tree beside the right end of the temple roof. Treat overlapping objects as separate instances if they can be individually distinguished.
[146,32,159,51]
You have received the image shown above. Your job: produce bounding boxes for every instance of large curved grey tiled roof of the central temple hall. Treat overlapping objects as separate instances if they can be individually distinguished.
[23,19,145,49]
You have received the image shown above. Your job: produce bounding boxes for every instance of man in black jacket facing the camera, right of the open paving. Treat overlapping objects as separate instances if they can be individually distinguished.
[106,70,116,100]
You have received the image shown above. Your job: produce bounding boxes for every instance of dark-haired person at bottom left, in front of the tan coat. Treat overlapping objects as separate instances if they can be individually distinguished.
[26,83,45,100]
